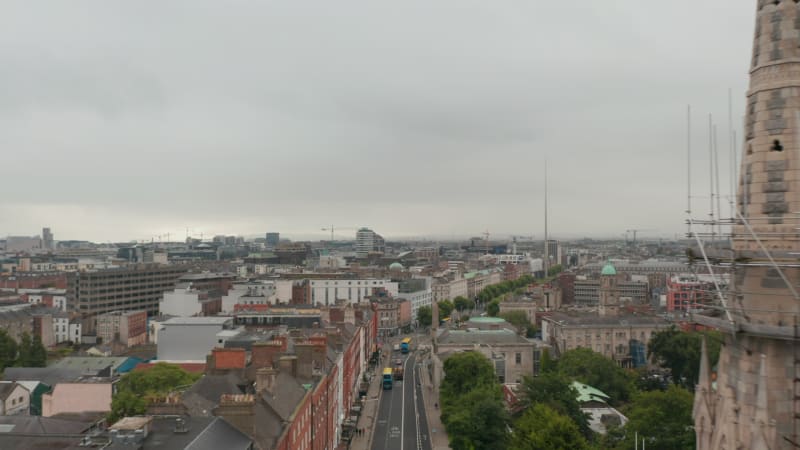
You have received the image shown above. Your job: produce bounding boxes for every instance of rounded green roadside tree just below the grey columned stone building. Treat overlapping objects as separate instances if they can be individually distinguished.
[441,351,497,396]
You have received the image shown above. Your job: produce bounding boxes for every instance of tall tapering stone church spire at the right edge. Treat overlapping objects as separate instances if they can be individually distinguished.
[694,0,800,450]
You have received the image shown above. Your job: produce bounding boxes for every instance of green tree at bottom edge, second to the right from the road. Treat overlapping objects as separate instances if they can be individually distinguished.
[509,403,589,450]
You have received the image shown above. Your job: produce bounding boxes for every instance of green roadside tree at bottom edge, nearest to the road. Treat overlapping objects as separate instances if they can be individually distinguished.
[442,384,510,450]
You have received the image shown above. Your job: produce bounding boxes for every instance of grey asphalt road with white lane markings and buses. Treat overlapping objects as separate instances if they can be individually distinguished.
[372,353,431,450]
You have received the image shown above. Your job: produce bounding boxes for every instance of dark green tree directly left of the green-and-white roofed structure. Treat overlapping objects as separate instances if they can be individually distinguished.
[521,372,592,438]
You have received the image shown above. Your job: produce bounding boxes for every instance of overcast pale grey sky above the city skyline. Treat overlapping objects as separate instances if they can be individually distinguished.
[0,0,756,241]
